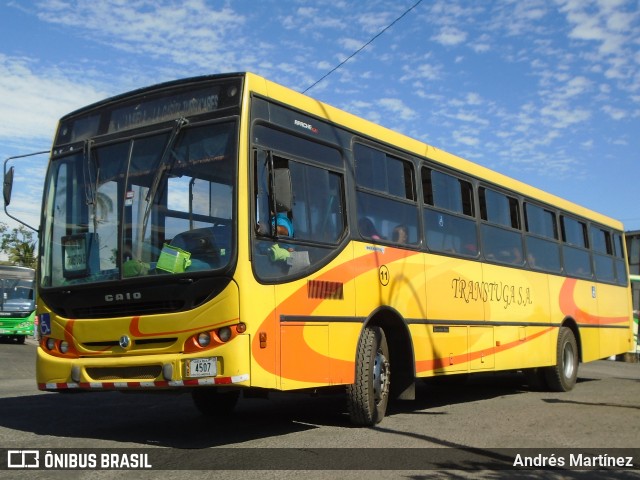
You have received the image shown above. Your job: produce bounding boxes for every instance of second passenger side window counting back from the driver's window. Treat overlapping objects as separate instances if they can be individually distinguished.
[421,167,478,257]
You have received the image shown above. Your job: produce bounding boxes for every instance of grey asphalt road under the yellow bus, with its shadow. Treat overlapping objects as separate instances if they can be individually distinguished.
[0,340,640,479]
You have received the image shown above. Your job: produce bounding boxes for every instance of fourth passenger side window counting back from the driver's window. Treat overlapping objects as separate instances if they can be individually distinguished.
[524,202,562,273]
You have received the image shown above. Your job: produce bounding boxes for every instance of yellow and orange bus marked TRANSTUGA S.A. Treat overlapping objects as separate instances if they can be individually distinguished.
[7,73,632,425]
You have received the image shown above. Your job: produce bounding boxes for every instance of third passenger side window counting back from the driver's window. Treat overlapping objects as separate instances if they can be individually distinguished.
[478,187,524,265]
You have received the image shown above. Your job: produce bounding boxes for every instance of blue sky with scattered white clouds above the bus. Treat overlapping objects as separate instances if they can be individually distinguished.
[0,0,640,230]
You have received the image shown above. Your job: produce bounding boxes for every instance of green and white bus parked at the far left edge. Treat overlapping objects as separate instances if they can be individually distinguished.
[0,265,36,343]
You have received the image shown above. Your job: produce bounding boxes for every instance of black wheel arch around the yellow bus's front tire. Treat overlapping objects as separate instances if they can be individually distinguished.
[360,306,416,400]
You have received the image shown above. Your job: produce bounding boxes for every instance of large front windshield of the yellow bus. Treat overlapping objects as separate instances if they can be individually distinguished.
[41,118,237,287]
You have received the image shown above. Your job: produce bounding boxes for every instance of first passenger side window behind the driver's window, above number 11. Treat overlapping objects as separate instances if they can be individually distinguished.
[353,143,420,245]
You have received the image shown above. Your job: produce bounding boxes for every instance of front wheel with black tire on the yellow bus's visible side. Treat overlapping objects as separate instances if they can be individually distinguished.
[347,327,391,426]
